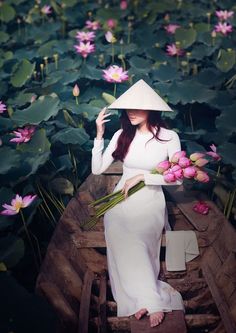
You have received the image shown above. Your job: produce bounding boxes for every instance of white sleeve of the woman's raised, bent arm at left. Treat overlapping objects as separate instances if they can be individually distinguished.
[91,129,122,175]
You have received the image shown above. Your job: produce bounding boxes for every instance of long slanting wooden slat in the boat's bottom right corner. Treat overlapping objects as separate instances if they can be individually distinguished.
[202,262,236,333]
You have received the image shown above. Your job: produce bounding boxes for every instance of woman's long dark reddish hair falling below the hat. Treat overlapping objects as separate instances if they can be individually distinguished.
[112,110,168,162]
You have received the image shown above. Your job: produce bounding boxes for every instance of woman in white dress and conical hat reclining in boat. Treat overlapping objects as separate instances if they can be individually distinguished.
[92,80,184,327]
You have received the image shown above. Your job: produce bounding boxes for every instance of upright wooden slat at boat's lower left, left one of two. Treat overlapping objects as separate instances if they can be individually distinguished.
[78,269,94,333]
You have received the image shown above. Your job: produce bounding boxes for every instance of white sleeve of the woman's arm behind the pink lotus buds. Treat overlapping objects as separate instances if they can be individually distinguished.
[144,131,183,185]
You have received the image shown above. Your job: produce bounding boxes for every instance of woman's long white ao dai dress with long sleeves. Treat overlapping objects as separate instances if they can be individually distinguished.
[92,127,184,317]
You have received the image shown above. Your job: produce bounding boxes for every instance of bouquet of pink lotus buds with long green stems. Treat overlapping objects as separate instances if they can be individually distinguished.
[83,145,220,230]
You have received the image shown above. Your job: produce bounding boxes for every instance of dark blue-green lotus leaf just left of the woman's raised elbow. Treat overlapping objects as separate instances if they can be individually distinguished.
[52,127,89,145]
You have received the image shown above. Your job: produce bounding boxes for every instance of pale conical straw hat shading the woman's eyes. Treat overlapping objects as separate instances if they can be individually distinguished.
[108,80,173,111]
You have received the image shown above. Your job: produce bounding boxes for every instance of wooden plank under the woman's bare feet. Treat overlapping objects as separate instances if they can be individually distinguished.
[130,311,187,333]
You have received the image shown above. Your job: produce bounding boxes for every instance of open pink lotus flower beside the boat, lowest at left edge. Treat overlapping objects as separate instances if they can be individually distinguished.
[0,194,37,215]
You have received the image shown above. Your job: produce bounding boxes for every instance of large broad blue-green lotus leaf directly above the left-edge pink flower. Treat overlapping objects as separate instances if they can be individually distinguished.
[12,96,59,126]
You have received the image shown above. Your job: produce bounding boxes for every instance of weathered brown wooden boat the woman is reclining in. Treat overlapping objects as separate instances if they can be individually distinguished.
[36,163,236,333]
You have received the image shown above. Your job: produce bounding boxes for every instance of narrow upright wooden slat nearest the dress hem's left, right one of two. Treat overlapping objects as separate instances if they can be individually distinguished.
[98,273,107,333]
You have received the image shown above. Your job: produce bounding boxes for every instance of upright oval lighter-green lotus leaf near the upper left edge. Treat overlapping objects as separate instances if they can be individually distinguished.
[11,59,35,88]
